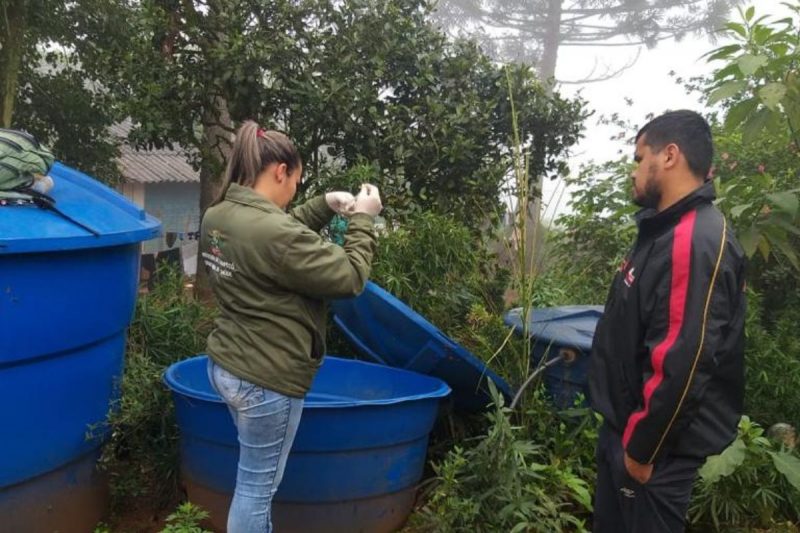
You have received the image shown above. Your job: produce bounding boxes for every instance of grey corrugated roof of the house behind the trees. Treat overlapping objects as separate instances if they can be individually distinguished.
[111,119,200,183]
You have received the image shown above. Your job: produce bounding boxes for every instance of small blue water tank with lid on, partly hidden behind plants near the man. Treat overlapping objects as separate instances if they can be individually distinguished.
[505,305,603,408]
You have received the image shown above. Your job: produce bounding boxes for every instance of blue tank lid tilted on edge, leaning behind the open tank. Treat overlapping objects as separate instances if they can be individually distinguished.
[331,281,511,411]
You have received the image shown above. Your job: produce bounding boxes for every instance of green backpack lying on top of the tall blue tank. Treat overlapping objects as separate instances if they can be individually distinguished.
[0,128,55,201]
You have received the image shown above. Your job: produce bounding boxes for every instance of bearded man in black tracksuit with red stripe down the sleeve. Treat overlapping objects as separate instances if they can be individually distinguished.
[589,111,745,533]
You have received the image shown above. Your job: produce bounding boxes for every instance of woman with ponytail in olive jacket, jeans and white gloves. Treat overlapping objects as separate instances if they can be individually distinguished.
[200,121,382,533]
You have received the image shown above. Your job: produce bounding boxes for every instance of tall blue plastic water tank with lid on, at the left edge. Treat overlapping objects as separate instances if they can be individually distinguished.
[0,164,160,532]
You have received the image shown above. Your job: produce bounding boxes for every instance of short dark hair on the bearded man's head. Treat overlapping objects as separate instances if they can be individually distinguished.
[636,109,714,179]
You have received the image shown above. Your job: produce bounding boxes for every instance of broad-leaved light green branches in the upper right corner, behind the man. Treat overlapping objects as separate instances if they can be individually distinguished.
[706,4,800,270]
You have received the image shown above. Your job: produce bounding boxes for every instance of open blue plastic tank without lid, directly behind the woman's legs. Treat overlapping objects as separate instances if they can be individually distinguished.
[164,356,450,533]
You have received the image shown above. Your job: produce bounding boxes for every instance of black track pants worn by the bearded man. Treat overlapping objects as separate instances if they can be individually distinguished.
[592,424,703,533]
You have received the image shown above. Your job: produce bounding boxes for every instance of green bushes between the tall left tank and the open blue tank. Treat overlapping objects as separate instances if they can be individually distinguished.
[101,267,212,509]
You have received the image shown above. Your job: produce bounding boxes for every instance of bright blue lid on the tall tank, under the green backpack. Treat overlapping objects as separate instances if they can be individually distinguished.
[0,163,161,255]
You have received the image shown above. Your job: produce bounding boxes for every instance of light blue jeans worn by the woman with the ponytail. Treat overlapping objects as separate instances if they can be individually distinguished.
[208,359,303,533]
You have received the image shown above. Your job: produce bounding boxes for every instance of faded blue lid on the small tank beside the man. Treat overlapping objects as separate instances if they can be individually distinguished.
[504,305,603,352]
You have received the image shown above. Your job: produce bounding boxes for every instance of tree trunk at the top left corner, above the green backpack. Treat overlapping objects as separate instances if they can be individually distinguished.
[0,0,28,128]
